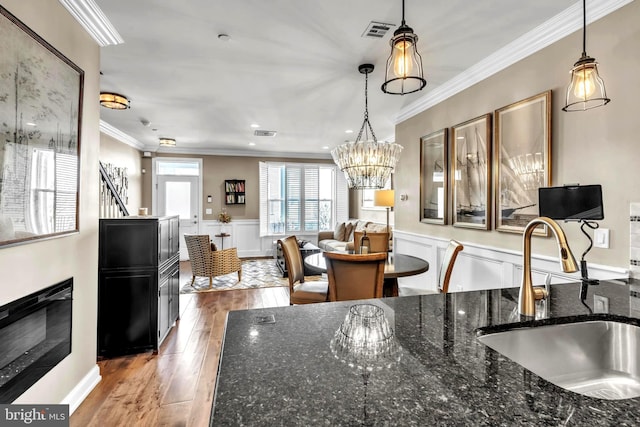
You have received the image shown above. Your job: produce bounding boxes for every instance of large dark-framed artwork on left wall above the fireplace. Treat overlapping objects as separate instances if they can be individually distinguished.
[0,6,84,245]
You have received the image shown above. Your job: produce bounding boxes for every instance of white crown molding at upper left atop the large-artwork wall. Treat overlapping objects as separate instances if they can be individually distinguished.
[58,0,124,47]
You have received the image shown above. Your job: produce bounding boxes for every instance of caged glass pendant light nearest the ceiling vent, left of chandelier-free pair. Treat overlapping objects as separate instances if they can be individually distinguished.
[382,0,427,95]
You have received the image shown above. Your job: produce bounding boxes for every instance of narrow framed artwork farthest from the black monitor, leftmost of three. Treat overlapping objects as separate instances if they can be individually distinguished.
[420,129,449,224]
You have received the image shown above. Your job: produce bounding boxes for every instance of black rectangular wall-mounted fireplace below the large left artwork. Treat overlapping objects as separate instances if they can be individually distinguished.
[0,278,73,403]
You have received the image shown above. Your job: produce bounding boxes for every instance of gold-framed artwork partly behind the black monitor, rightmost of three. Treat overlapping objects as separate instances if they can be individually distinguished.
[494,90,551,236]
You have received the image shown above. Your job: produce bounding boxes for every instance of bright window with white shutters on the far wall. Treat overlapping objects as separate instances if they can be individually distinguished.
[260,162,349,236]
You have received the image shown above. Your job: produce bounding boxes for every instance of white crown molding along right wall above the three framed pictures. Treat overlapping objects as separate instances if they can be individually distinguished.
[395,0,633,124]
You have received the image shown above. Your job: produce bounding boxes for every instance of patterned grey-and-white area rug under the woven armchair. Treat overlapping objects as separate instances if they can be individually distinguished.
[180,259,289,294]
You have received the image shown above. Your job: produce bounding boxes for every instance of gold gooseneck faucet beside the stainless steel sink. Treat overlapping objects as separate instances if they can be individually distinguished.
[518,216,578,317]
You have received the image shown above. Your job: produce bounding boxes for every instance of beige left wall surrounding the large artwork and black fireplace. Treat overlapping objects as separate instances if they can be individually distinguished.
[0,0,100,410]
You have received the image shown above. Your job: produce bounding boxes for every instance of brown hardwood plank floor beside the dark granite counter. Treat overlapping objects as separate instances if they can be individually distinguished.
[70,262,289,427]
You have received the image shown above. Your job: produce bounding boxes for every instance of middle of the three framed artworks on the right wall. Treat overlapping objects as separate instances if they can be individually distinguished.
[451,114,491,230]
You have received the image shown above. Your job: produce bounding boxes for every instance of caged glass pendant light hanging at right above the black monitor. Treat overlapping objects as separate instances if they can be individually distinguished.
[562,0,611,111]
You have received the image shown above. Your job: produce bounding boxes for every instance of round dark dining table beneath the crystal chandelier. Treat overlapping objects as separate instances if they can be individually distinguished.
[304,252,429,297]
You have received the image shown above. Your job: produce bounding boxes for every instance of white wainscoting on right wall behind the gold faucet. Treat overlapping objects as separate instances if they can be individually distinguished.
[393,230,629,295]
